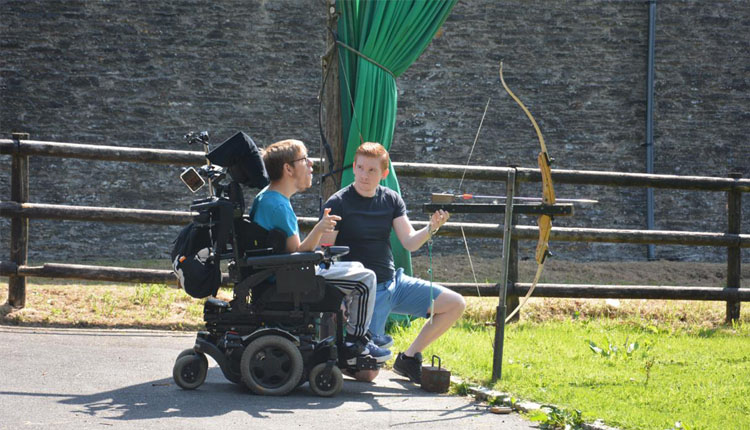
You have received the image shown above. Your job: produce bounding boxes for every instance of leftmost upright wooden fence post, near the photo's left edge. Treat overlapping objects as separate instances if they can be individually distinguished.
[8,133,29,308]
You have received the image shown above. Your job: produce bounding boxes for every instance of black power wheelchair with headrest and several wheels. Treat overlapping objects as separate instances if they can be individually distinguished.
[172,133,379,396]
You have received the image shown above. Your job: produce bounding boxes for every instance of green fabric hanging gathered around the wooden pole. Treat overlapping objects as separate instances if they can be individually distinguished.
[336,0,458,275]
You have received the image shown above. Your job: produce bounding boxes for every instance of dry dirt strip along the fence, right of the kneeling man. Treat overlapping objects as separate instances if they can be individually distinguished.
[412,255,750,330]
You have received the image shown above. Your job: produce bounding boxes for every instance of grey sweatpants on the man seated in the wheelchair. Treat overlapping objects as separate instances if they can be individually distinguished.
[315,261,375,337]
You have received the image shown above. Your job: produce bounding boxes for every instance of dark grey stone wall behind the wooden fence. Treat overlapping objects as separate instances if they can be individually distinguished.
[0,0,750,262]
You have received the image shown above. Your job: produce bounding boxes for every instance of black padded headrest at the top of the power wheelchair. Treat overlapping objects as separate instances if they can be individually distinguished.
[206,132,269,188]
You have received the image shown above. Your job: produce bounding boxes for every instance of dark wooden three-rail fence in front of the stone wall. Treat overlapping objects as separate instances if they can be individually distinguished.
[0,133,750,321]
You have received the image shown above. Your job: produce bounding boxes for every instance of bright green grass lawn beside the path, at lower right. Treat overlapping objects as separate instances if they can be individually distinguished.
[392,318,750,430]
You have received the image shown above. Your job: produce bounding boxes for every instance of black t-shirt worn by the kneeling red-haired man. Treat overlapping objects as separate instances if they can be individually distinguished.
[324,185,406,283]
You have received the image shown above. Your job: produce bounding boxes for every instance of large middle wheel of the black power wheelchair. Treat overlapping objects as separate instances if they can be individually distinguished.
[240,335,304,396]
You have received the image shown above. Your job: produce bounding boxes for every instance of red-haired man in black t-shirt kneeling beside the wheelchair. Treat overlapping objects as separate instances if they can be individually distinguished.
[323,142,466,383]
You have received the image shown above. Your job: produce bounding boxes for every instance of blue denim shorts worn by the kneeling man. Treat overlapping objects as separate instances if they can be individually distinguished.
[370,269,446,335]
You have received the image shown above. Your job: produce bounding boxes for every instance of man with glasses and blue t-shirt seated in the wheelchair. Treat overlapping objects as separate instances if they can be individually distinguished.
[250,139,391,364]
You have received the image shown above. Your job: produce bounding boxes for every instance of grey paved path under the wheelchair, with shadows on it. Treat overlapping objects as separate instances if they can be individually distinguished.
[0,326,536,430]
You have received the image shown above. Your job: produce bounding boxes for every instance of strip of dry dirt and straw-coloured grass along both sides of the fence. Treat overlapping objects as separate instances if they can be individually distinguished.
[0,255,750,331]
